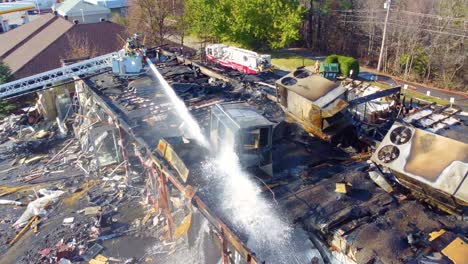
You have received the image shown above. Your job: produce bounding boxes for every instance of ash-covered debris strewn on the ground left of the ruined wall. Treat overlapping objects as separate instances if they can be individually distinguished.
[0,86,177,263]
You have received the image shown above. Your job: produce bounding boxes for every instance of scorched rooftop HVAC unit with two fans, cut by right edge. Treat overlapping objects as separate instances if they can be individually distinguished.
[371,122,468,214]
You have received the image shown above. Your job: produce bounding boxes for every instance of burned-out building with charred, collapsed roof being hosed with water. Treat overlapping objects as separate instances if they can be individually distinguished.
[0,48,468,263]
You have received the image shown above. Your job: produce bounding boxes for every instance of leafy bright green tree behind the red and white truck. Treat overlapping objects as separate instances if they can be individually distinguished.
[185,0,304,49]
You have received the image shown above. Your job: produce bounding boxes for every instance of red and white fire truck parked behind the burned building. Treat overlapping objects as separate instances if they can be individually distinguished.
[205,44,271,74]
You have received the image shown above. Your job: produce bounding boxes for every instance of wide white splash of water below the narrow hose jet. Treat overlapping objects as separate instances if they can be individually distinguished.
[203,142,294,263]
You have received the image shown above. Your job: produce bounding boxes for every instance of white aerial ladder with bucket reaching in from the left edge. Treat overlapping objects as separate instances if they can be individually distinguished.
[0,34,145,99]
